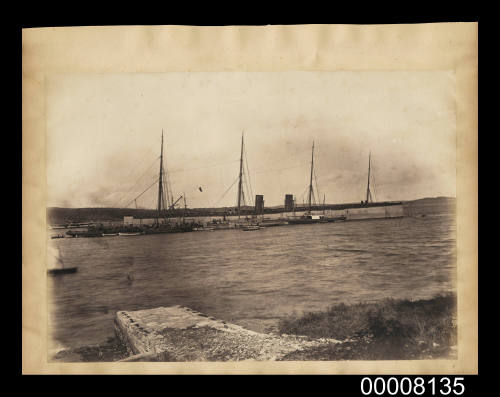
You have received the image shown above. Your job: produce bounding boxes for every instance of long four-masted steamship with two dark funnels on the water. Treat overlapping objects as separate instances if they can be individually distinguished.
[51,131,404,226]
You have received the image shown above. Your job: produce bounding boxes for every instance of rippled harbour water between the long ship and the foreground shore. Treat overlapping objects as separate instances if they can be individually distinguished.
[48,203,456,351]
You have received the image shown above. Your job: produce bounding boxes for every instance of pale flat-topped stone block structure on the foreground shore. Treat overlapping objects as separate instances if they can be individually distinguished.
[115,306,342,361]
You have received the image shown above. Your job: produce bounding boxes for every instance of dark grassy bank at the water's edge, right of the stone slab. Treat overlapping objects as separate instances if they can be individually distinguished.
[279,294,457,360]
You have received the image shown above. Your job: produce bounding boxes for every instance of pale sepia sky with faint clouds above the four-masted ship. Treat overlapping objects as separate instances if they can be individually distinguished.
[46,71,456,208]
